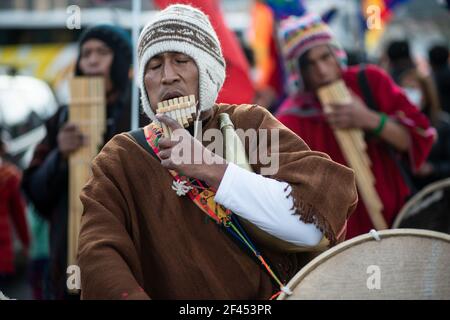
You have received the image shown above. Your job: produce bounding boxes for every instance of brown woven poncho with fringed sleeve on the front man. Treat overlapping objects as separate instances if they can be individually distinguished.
[78,104,357,299]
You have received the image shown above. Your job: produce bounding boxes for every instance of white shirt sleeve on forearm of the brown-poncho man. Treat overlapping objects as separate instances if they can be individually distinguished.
[214,163,323,246]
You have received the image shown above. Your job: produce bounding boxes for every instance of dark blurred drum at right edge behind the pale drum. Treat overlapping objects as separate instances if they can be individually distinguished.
[392,178,450,234]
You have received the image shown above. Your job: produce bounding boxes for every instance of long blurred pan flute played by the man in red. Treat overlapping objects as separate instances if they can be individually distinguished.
[318,80,388,230]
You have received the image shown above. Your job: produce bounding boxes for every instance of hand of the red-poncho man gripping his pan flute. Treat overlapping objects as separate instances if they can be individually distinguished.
[326,94,380,130]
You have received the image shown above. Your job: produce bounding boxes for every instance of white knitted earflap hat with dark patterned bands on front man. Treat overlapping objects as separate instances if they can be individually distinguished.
[138,4,225,120]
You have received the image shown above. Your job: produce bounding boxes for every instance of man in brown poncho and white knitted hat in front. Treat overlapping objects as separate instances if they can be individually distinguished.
[78,5,357,299]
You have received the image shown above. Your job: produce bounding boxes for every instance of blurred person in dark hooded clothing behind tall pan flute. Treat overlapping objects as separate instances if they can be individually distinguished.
[23,24,144,299]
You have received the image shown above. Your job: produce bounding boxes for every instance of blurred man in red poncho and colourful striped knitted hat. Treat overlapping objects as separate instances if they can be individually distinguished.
[276,14,435,238]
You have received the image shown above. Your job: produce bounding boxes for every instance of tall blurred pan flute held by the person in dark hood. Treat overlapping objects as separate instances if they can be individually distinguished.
[67,77,106,272]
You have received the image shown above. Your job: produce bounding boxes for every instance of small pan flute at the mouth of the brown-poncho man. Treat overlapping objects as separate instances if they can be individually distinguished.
[156,95,197,137]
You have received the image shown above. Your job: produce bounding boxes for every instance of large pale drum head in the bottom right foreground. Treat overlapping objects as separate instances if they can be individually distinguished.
[279,229,450,300]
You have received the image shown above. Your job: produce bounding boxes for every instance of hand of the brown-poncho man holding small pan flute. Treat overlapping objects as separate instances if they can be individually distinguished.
[156,115,227,189]
